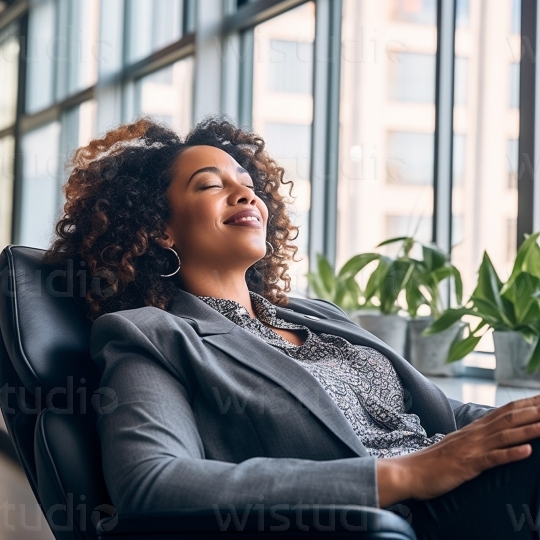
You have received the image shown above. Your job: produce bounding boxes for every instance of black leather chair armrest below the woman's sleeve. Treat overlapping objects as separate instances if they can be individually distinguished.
[96,504,416,540]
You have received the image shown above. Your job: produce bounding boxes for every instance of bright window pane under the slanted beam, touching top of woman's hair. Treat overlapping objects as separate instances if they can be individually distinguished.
[135,56,193,135]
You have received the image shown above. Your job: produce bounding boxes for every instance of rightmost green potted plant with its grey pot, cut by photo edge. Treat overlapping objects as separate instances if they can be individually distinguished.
[426,232,540,388]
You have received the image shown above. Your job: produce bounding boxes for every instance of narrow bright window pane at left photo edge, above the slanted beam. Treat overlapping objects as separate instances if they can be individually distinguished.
[0,26,19,129]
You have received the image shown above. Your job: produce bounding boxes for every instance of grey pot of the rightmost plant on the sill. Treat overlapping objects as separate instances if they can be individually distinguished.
[493,330,540,388]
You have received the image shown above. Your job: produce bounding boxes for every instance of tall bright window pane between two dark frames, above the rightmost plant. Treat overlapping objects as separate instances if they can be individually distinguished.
[452,0,520,351]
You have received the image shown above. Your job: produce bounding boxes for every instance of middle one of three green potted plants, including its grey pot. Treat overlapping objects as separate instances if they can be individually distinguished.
[381,236,465,376]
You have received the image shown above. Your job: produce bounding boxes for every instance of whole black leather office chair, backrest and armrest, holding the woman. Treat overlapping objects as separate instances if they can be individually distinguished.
[0,246,416,540]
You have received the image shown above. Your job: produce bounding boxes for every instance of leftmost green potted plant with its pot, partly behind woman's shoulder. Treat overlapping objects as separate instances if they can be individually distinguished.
[308,253,410,356]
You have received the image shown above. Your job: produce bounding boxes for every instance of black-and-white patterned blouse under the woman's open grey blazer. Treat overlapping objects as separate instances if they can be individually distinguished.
[198,291,444,458]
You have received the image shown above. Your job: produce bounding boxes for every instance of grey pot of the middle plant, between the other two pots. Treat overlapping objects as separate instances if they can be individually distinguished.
[408,317,465,377]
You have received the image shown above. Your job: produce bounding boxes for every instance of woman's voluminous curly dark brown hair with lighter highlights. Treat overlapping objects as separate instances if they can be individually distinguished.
[44,117,298,320]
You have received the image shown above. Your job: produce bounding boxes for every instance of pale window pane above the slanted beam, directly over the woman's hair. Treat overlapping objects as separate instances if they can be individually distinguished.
[126,0,184,63]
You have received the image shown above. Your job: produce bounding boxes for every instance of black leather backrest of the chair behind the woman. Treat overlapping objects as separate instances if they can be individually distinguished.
[0,246,114,540]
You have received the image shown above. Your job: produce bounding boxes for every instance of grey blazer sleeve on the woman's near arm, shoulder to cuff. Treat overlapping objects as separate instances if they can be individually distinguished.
[91,312,379,513]
